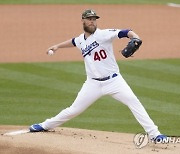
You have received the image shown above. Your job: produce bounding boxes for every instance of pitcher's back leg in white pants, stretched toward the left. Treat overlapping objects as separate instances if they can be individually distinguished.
[38,80,102,130]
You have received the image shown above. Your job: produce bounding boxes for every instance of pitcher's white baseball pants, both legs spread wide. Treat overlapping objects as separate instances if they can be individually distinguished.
[41,74,160,138]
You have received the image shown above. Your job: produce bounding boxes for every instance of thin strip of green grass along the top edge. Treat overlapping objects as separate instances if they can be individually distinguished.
[0,0,180,4]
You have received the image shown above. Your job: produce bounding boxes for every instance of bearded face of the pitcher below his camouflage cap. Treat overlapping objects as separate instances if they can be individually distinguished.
[82,17,97,34]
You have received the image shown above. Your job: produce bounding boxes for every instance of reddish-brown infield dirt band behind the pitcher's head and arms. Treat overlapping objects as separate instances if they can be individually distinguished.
[0,5,180,62]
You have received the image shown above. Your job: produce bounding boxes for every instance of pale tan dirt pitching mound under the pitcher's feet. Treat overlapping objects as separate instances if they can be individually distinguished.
[0,126,180,154]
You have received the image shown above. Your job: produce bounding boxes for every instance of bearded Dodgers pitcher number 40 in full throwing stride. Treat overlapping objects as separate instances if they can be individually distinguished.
[30,9,166,141]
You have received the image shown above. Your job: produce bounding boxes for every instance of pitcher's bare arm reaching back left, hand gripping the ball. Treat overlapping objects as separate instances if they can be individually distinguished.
[47,39,75,54]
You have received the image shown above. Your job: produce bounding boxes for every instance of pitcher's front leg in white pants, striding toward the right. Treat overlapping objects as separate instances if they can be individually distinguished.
[112,76,160,138]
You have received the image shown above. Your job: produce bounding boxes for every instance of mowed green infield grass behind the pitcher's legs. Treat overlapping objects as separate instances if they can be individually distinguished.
[0,59,180,135]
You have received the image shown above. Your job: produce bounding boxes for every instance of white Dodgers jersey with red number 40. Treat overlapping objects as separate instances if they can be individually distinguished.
[74,29,120,78]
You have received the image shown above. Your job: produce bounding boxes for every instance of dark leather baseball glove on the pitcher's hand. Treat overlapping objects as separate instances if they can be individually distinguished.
[121,38,142,58]
